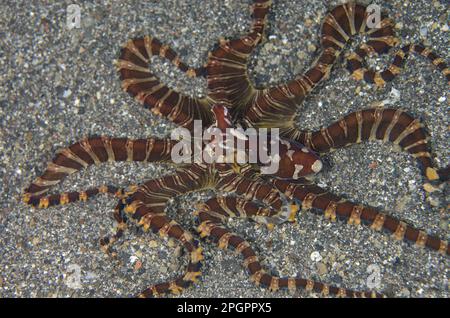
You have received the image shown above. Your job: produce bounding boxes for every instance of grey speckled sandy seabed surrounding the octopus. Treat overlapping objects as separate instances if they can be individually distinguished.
[0,0,450,297]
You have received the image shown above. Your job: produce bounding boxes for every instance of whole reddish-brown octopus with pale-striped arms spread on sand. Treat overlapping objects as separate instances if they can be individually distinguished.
[24,0,450,297]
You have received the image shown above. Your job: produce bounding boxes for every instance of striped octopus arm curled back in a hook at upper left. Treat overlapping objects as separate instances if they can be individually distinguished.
[116,36,213,129]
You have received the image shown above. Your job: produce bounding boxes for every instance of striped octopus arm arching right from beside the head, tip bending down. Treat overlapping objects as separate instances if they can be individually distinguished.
[286,108,449,185]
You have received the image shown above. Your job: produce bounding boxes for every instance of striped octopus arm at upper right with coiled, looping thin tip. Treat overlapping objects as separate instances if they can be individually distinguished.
[243,3,450,130]
